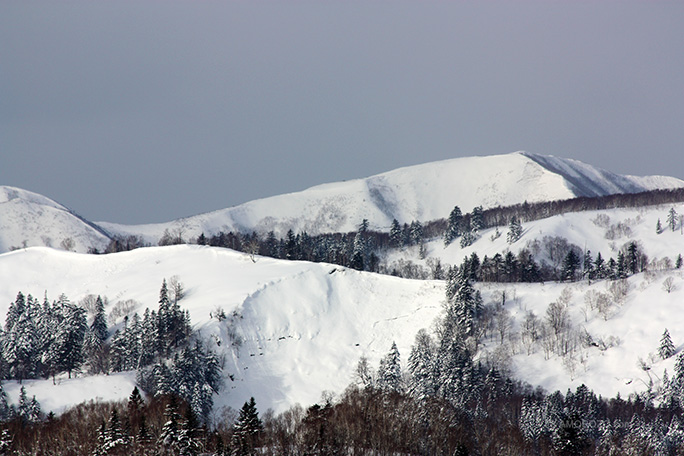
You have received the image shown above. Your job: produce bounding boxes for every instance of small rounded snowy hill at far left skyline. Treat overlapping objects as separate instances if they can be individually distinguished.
[0,186,109,252]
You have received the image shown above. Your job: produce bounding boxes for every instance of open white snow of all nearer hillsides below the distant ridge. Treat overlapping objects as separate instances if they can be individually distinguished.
[0,207,684,411]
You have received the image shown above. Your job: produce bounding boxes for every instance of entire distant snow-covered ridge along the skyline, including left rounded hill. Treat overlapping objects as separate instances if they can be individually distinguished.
[0,152,684,253]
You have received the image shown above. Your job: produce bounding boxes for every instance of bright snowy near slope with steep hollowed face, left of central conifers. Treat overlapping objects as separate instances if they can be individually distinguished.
[0,246,443,411]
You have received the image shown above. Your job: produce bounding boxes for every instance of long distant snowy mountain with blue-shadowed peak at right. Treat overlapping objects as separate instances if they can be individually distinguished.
[99,152,684,243]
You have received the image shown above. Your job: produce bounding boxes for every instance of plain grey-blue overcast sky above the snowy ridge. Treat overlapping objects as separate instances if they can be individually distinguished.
[0,0,684,224]
